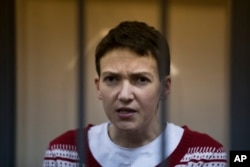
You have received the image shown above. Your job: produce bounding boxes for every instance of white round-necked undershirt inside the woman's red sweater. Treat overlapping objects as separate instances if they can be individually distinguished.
[88,122,184,167]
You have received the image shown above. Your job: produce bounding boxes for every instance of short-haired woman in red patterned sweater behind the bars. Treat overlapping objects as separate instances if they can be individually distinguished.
[43,21,226,167]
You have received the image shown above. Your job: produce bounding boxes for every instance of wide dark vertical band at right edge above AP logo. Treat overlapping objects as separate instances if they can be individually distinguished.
[230,0,250,150]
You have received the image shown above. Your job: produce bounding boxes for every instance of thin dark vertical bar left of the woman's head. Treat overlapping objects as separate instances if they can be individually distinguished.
[76,0,86,167]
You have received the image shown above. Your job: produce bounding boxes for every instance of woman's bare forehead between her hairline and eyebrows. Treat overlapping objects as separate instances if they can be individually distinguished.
[100,48,158,75]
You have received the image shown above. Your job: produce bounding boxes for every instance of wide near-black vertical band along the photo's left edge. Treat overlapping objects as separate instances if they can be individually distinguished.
[0,0,17,167]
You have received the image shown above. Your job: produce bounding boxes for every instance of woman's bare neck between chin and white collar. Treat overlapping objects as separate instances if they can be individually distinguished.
[109,121,164,148]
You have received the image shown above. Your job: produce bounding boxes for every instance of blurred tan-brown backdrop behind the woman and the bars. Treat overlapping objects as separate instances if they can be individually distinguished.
[17,0,228,167]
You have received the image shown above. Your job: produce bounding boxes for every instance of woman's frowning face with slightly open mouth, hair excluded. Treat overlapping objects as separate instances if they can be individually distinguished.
[95,49,169,131]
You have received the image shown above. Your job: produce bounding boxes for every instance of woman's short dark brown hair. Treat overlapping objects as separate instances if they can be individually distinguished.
[95,21,170,79]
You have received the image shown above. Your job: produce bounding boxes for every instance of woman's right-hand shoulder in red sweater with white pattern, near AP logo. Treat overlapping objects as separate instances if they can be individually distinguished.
[173,126,227,166]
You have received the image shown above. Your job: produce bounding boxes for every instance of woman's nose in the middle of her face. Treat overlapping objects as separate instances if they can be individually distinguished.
[118,81,134,103]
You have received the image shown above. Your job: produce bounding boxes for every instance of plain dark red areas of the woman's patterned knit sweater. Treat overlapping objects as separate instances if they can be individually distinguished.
[44,124,226,167]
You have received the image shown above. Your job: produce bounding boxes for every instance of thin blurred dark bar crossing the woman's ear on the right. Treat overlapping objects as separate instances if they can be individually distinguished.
[159,0,168,167]
